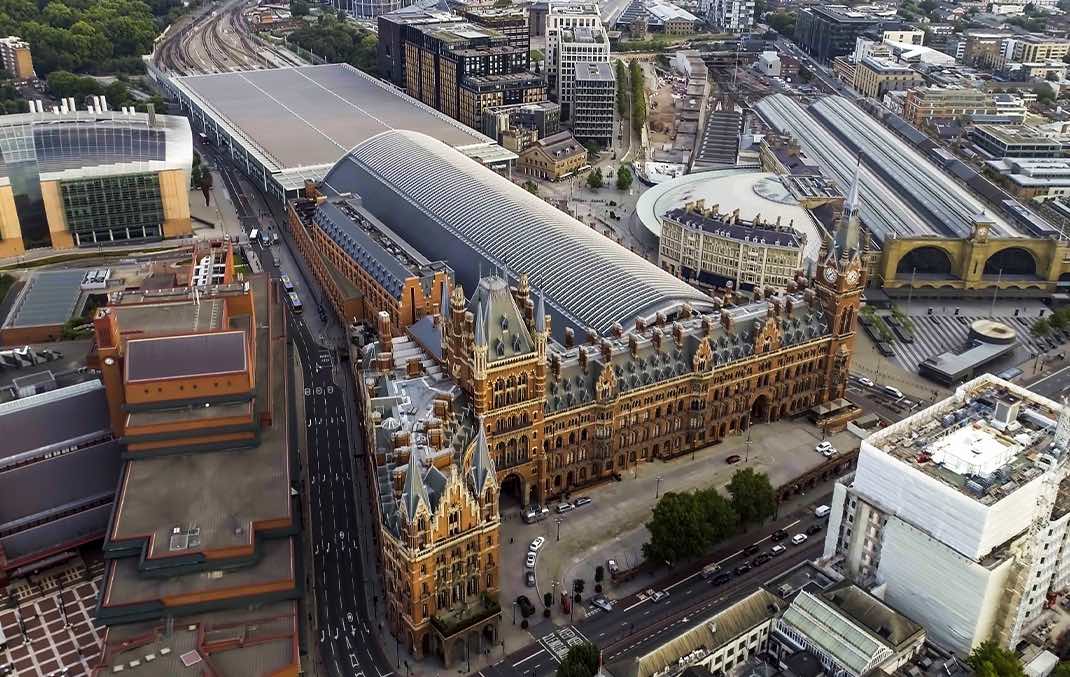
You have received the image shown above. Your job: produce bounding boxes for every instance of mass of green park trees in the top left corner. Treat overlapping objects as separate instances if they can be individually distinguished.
[0,0,175,76]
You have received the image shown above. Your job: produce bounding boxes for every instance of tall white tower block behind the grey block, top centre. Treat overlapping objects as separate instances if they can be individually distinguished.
[546,2,609,121]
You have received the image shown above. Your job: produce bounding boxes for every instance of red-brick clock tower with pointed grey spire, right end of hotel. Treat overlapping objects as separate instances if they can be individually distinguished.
[814,155,869,398]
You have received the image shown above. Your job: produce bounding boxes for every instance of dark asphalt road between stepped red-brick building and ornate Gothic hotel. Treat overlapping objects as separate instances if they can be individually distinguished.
[208,140,394,677]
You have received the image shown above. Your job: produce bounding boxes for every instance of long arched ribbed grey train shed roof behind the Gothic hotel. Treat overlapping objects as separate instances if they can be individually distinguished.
[324,130,712,340]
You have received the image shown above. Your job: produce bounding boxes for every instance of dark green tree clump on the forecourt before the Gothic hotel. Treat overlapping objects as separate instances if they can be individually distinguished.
[643,467,777,564]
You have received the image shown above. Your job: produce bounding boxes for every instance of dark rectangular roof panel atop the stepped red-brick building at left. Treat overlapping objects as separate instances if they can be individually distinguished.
[126,332,248,383]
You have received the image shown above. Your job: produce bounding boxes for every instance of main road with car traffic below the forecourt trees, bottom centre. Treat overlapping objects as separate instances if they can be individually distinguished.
[478,496,830,677]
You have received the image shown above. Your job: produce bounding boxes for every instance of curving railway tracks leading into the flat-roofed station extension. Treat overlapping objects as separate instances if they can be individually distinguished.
[153,1,304,75]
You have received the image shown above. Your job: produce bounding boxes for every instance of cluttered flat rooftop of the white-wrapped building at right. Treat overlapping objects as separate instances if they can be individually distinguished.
[868,374,1058,505]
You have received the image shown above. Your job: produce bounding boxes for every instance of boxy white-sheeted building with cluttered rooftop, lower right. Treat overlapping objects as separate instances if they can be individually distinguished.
[824,374,1070,653]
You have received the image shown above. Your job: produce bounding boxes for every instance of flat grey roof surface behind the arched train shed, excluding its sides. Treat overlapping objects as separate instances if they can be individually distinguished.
[173,63,493,173]
